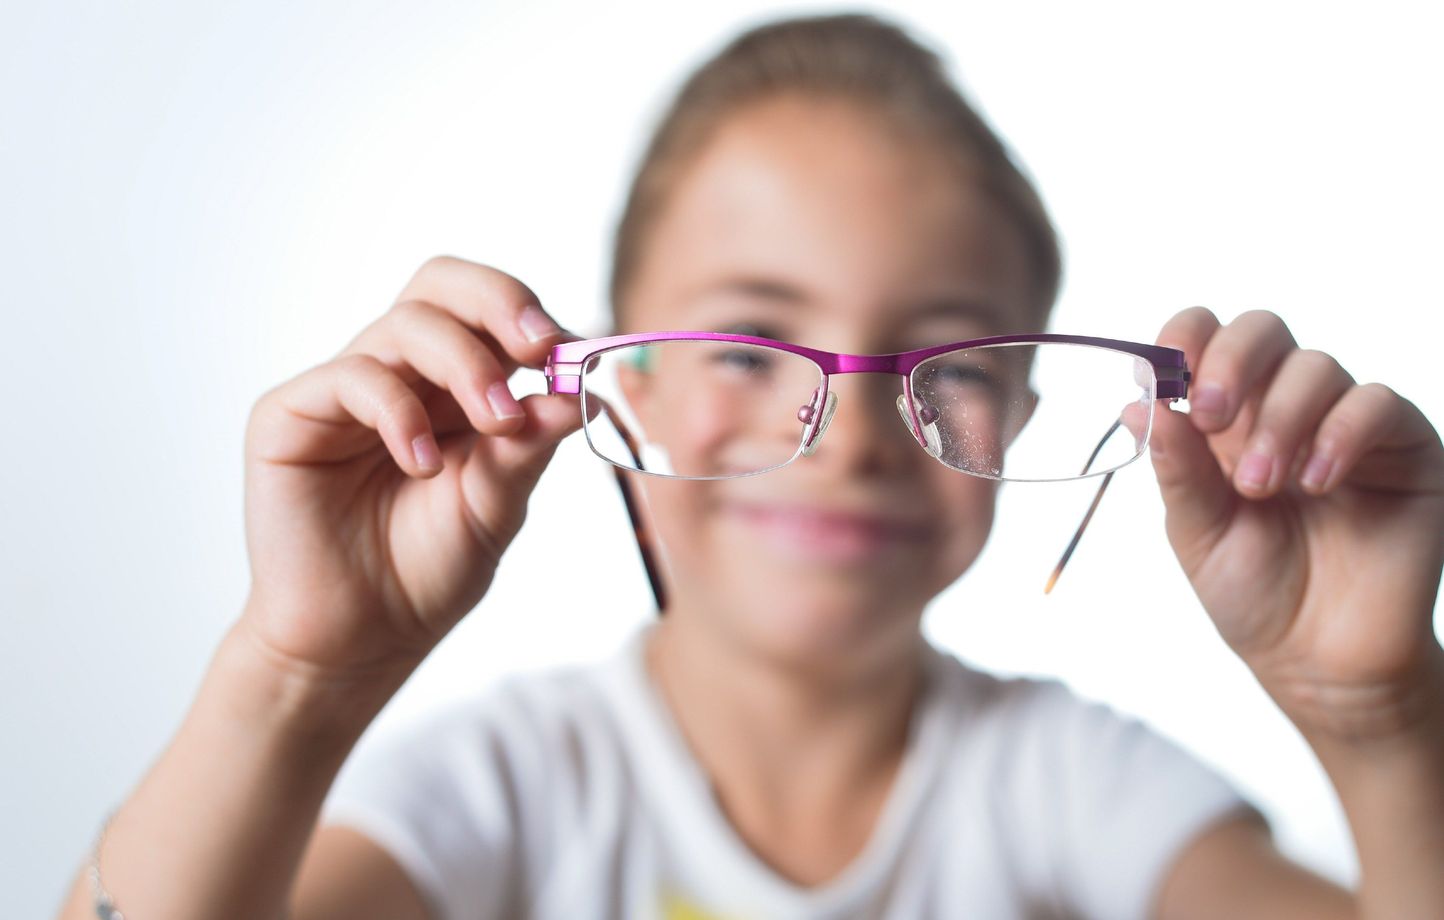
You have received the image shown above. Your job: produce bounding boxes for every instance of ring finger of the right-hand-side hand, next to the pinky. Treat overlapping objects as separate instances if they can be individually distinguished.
[1233,348,1354,498]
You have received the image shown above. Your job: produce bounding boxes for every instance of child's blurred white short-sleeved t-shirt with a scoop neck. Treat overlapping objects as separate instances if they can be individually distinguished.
[321,624,1252,920]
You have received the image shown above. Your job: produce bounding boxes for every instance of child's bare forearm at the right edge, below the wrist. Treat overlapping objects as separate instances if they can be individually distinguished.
[1301,647,1444,920]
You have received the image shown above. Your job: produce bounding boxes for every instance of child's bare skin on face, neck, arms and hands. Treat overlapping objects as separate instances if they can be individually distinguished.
[61,98,1444,920]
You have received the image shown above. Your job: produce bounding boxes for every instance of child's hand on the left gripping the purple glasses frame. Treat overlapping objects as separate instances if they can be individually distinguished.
[237,256,582,679]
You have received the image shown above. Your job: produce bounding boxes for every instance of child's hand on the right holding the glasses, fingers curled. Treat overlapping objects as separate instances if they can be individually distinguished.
[1151,308,1444,737]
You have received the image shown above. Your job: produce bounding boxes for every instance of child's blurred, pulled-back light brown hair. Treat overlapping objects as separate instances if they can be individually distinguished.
[611,14,1063,331]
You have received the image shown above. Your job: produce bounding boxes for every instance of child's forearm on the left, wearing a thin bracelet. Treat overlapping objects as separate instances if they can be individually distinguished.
[50,609,404,920]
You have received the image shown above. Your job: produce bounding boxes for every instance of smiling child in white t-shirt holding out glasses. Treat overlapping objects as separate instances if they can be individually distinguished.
[64,16,1444,920]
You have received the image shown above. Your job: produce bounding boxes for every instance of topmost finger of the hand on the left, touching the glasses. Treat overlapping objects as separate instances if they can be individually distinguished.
[397,256,577,376]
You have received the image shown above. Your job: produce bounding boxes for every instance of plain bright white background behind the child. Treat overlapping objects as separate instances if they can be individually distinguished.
[0,0,1444,920]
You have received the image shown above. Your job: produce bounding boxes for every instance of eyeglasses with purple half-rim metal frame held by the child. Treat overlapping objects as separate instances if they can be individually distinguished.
[546,332,1191,608]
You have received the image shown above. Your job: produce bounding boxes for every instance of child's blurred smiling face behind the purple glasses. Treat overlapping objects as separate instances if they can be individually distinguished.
[622,98,1038,664]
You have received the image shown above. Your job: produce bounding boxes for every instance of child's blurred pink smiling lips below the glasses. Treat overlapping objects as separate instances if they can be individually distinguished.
[725,503,931,563]
